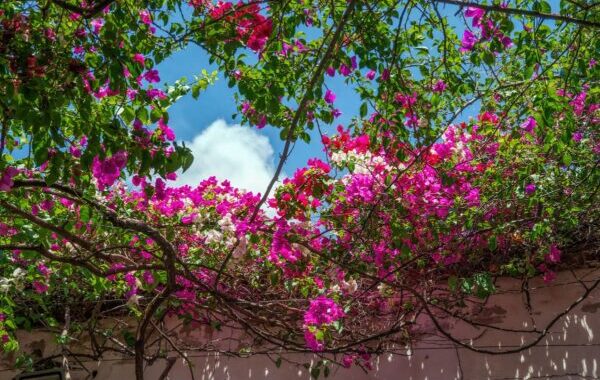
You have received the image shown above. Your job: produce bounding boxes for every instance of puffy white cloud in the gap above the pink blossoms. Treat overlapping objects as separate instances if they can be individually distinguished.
[176,119,275,194]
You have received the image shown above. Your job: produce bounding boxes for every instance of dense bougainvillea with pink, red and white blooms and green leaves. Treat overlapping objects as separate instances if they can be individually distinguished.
[0,0,600,378]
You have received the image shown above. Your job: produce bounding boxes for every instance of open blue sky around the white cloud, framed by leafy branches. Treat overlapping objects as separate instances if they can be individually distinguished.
[158,45,360,192]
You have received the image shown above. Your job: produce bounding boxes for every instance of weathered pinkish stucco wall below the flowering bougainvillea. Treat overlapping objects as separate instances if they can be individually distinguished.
[0,269,600,380]
